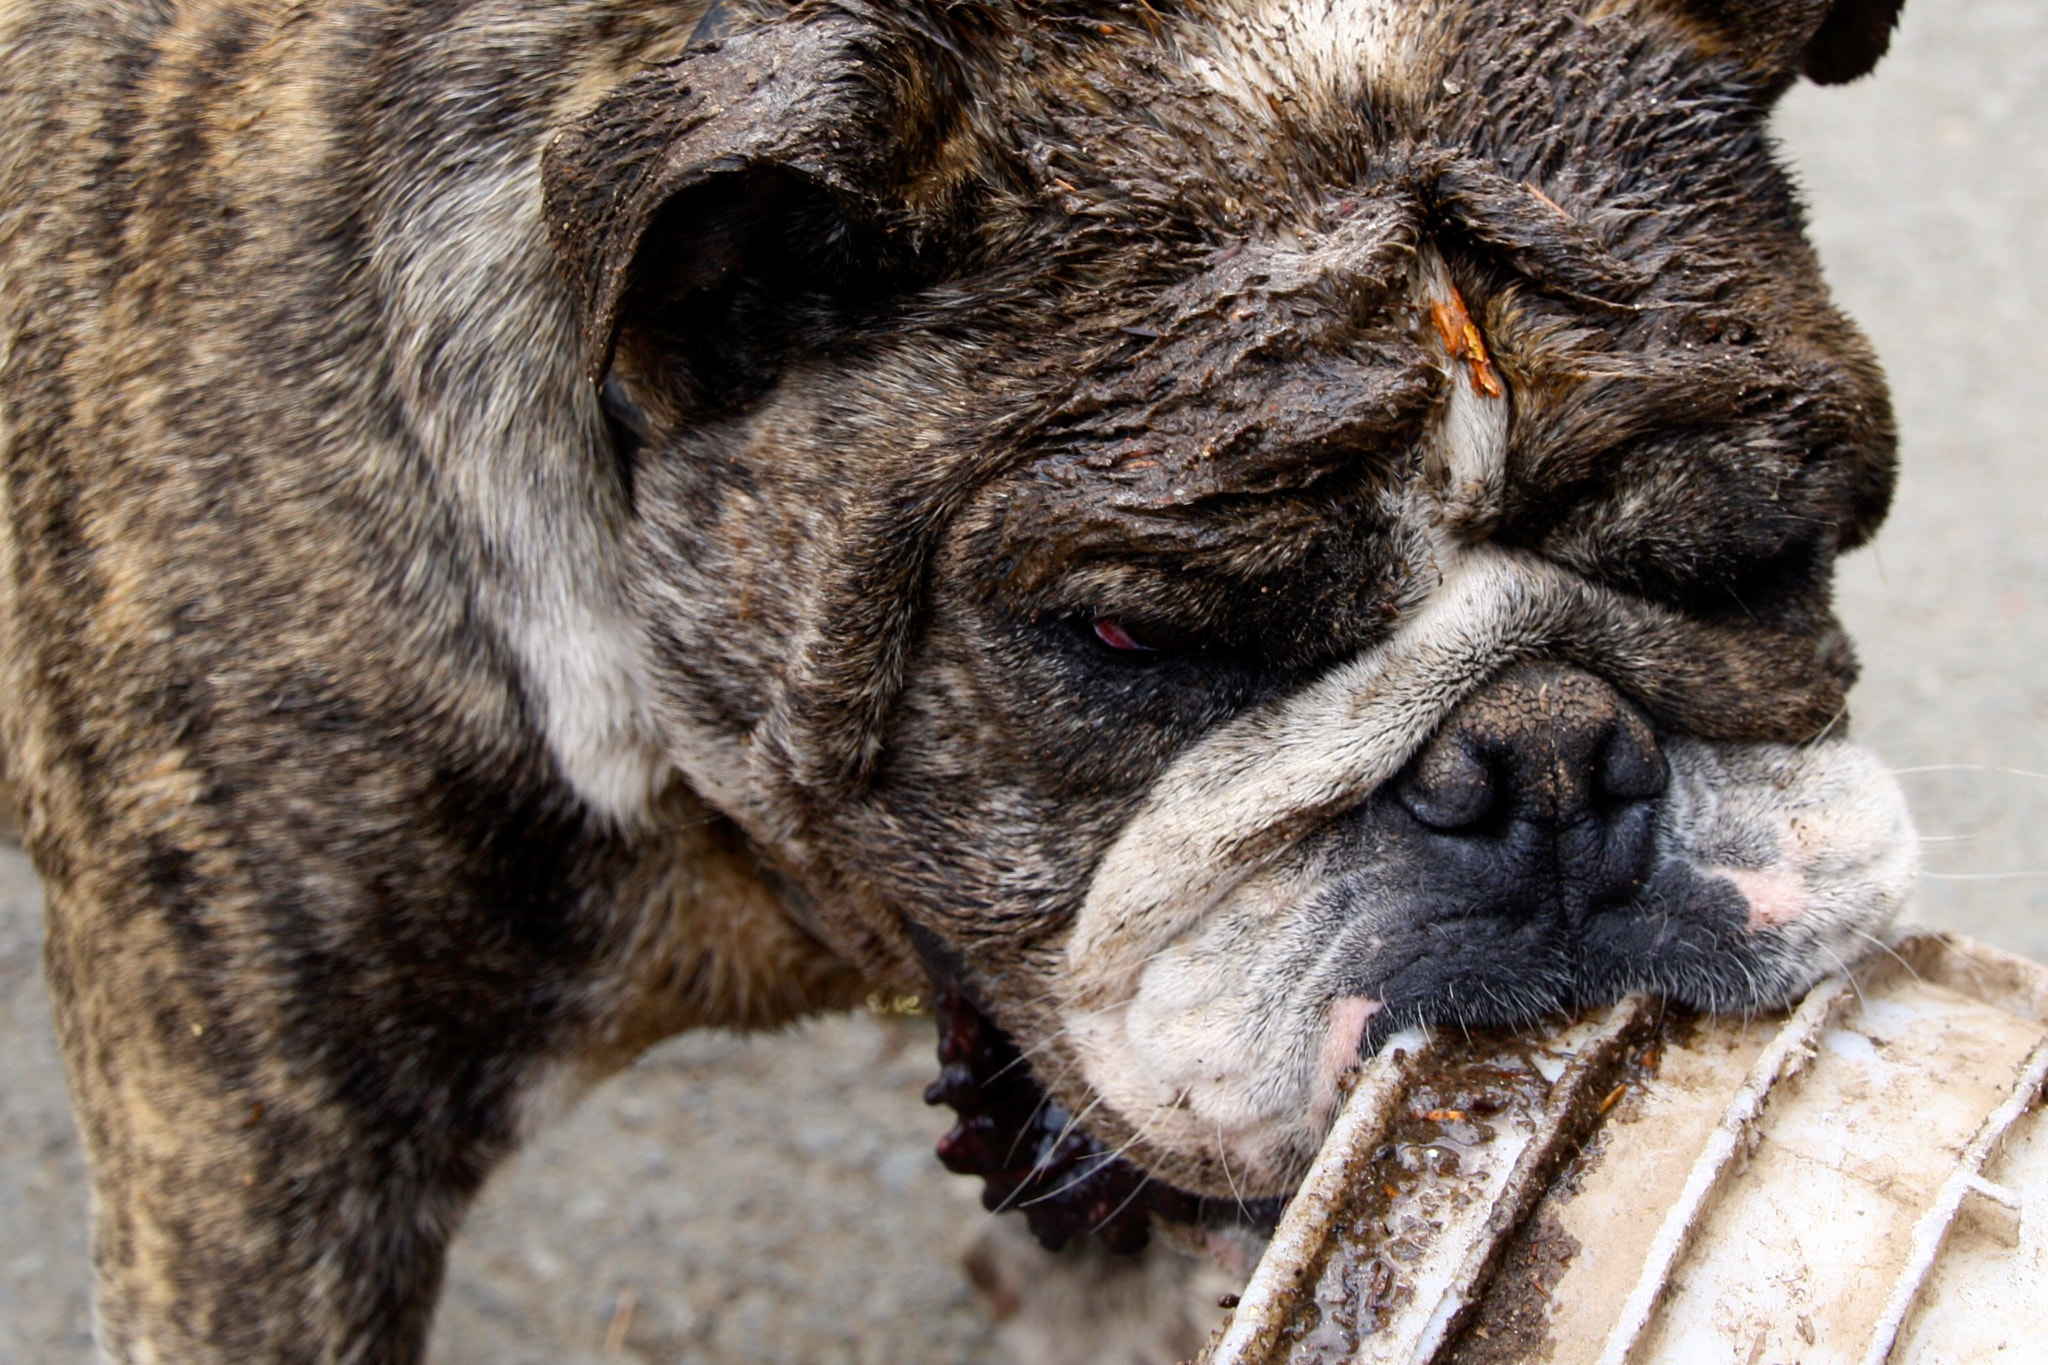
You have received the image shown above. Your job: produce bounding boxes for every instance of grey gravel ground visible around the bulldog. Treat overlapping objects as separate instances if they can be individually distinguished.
[0,0,2048,1365]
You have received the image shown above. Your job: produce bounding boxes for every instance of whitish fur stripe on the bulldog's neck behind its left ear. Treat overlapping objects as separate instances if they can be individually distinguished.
[375,156,666,823]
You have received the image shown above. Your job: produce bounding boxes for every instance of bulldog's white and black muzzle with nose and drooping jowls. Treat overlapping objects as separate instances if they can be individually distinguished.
[1059,546,1915,1195]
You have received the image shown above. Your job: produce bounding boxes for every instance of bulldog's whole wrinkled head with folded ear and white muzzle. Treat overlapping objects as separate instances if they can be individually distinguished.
[547,0,1913,1195]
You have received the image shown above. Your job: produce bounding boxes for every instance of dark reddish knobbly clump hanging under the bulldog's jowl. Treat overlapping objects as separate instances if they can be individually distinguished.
[924,986,1284,1254]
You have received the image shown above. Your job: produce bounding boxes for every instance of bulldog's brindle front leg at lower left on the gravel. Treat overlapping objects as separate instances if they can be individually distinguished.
[47,875,507,1365]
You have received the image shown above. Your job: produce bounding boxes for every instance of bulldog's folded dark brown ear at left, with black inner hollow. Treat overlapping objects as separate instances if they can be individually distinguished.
[541,10,958,388]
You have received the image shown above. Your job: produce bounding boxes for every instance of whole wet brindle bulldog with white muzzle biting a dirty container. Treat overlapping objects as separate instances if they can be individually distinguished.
[0,0,1913,1363]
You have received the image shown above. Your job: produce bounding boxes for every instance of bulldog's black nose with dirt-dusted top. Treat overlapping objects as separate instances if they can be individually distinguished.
[1395,663,1669,915]
